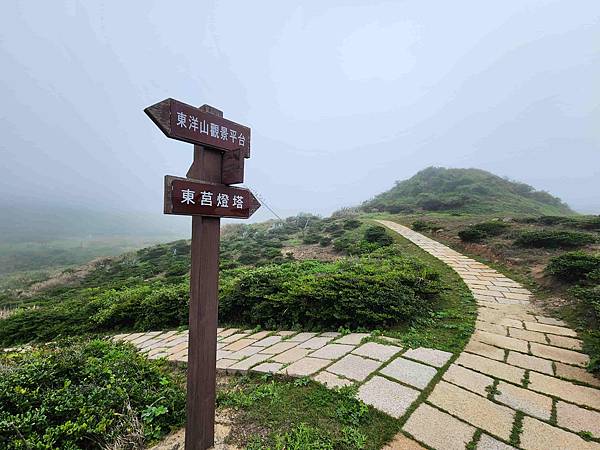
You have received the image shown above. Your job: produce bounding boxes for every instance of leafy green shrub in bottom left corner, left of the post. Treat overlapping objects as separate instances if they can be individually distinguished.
[0,340,185,450]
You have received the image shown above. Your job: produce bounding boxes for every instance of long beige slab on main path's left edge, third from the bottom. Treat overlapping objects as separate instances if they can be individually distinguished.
[427,380,514,440]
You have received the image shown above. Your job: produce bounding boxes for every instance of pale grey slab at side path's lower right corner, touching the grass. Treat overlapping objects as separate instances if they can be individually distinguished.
[358,376,419,419]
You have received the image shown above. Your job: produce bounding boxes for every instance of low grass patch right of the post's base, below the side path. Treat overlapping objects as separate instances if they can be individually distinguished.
[217,374,399,450]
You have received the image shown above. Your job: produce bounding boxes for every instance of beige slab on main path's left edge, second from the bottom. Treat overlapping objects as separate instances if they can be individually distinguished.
[403,403,475,450]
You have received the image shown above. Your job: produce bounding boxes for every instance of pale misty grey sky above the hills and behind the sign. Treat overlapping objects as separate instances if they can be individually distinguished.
[0,0,600,225]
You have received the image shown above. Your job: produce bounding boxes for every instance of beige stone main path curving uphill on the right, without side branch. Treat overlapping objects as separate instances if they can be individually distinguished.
[379,220,600,450]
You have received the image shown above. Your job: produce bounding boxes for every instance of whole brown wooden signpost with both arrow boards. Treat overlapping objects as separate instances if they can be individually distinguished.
[144,99,260,450]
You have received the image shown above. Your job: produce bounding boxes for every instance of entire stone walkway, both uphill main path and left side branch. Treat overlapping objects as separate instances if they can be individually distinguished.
[115,220,600,450]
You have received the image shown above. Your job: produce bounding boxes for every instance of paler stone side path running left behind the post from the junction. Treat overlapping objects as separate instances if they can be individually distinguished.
[113,328,452,418]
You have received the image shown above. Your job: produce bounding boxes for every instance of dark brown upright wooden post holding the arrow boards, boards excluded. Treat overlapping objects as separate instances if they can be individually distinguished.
[185,145,222,450]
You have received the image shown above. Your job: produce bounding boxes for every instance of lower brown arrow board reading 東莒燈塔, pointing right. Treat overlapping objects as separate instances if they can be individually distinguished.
[165,175,260,219]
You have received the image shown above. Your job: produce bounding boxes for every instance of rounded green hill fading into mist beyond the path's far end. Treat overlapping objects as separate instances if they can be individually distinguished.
[361,167,574,215]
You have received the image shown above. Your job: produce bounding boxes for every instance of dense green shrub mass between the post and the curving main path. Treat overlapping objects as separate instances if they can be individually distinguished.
[219,248,440,329]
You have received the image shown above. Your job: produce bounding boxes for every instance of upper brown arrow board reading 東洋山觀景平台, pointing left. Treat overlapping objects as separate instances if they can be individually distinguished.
[144,98,250,158]
